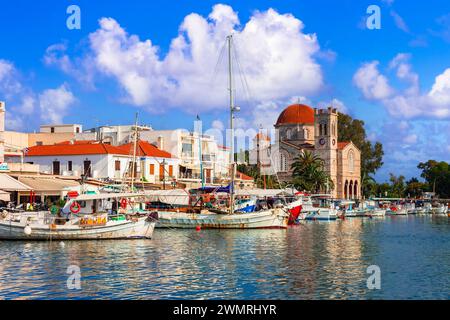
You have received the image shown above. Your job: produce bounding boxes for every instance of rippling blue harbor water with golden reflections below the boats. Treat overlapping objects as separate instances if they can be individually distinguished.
[0,215,450,299]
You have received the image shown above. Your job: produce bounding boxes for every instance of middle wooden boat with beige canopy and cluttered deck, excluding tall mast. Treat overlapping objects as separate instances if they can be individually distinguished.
[145,186,295,229]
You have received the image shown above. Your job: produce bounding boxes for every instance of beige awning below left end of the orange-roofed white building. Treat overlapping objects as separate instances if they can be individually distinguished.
[19,176,80,196]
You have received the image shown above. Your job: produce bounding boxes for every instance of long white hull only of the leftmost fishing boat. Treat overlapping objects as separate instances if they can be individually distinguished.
[0,217,156,240]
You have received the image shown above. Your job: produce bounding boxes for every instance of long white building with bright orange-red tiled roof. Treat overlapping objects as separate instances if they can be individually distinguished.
[8,141,178,184]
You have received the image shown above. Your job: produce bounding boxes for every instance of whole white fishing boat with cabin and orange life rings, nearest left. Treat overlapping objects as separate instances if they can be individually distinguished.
[0,193,156,240]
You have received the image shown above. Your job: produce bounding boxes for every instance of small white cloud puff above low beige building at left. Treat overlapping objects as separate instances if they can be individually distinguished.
[39,84,75,124]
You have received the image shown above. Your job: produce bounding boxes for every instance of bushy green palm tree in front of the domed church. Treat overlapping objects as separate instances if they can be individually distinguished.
[292,150,334,192]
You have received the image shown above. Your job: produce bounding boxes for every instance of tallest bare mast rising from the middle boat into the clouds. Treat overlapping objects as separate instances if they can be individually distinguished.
[227,35,236,214]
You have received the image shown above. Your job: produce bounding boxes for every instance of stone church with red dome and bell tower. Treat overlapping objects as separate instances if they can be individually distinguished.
[250,104,361,199]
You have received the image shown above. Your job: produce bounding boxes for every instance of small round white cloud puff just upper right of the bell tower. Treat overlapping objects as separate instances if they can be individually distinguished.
[353,61,394,100]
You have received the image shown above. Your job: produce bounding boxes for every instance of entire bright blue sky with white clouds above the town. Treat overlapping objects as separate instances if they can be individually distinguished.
[0,0,450,181]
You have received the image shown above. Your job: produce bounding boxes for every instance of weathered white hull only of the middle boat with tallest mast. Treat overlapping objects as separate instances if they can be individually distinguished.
[156,209,289,229]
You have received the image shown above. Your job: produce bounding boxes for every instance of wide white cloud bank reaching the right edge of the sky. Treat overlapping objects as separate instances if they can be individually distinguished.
[354,53,450,119]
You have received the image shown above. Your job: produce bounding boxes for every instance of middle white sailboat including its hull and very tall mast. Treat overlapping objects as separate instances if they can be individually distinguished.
[157,35,290,229]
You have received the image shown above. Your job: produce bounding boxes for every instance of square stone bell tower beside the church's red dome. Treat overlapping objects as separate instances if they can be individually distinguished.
[314,107,338,197]
